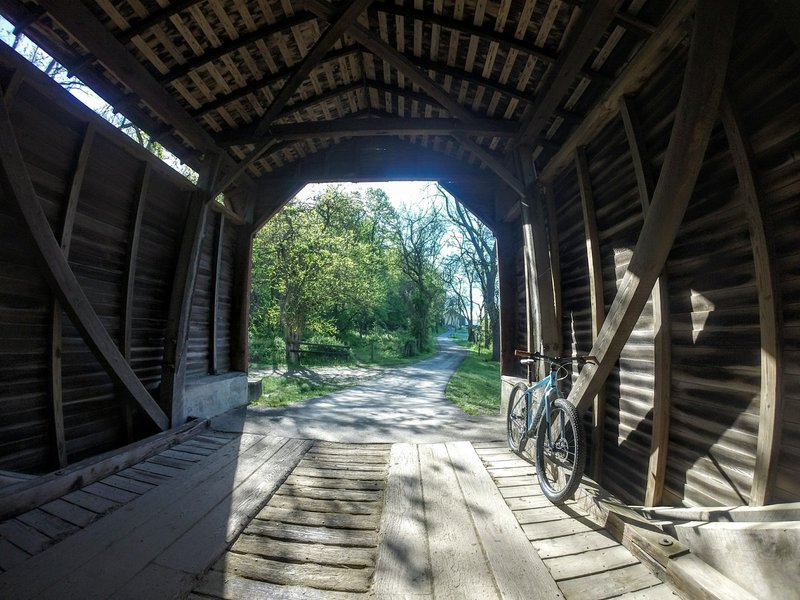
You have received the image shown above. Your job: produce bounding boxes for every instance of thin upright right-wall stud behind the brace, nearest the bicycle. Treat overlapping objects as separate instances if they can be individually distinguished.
[575,146,606,483]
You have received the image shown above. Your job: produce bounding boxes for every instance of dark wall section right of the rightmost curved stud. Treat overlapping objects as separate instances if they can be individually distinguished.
[728,3,800,502]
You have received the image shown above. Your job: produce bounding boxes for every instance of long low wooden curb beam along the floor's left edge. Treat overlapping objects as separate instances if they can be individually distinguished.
[0,419,208,521]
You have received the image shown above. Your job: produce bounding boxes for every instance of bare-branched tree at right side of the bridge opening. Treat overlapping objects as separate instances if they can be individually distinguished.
[438,187,500,360]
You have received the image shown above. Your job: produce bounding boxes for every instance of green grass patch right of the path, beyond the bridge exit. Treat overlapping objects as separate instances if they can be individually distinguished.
[447,346,500,415]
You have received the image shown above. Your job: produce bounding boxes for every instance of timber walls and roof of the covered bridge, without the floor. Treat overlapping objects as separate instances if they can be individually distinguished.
[0,0,800,589]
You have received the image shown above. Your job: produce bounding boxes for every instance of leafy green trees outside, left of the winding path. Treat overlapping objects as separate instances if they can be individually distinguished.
[250,186,444,364]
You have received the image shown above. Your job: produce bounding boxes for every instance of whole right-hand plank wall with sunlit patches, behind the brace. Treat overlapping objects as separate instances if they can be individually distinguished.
[545,3,800,505]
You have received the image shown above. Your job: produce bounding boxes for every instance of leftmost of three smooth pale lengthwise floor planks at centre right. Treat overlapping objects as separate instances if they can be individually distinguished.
[373,444,433,598]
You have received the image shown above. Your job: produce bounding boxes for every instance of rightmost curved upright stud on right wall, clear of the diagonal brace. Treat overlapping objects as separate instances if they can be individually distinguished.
[720,93,783,506]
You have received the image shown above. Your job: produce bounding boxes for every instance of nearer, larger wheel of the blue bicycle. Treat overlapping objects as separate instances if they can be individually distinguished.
[536,398,586,504]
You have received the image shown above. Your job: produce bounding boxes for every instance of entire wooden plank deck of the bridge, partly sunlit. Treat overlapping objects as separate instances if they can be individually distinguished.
[0,431,675,599]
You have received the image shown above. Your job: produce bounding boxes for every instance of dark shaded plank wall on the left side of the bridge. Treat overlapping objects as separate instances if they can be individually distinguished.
[0,47,242,472]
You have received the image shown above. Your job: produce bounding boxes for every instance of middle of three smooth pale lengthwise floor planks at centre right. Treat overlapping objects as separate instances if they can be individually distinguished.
[419,444,498,599]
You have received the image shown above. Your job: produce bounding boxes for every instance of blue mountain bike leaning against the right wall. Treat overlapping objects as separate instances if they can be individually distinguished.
[506,350,596,504]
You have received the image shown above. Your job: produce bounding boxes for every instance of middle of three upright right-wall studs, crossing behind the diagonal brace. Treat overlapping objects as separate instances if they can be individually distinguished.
[619,96,672,506]
